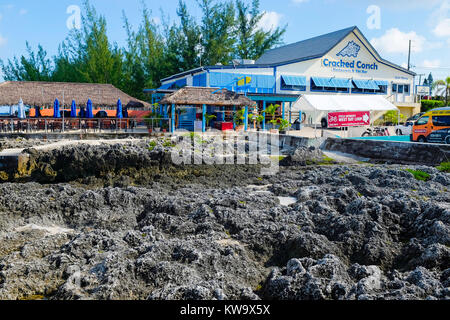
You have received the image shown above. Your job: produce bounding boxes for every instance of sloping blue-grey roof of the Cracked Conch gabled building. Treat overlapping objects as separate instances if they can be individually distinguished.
[256,26,356,64]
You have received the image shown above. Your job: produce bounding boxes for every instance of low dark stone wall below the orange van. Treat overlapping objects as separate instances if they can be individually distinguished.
[321,138,450,165]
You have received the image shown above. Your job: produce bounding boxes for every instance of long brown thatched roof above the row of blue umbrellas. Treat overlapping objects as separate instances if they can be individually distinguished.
[0,81,150,108]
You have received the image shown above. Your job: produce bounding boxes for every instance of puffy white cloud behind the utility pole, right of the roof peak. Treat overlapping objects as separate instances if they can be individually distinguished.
[370,28,443,53]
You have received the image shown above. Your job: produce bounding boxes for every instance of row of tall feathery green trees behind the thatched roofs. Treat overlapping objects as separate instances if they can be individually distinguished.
[0,0,286,98]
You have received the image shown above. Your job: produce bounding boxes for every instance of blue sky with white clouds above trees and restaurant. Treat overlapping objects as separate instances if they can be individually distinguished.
[0,0,450,79]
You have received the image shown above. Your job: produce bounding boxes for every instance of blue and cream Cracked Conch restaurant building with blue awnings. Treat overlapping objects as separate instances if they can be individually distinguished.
[146,26,420,129]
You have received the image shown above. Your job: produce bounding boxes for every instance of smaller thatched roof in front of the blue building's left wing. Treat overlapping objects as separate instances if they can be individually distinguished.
[159,87,256,107]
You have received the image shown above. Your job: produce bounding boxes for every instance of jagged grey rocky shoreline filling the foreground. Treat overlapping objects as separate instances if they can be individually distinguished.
[0,140,450,300]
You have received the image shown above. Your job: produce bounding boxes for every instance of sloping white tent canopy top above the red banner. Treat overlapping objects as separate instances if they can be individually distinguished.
[292,94,398,112]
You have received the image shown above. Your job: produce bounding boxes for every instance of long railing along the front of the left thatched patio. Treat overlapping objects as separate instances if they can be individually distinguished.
[0,118,171,133]
